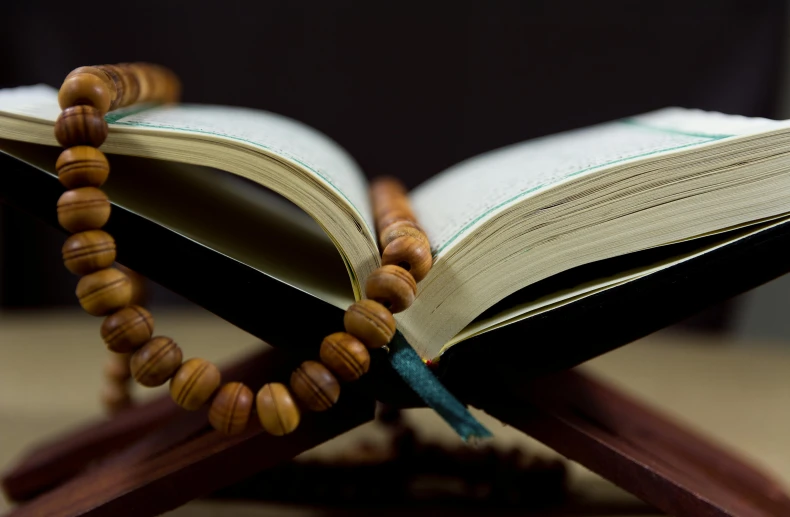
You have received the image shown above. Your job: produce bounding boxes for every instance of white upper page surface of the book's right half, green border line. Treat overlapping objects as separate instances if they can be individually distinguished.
[411,108,784,258]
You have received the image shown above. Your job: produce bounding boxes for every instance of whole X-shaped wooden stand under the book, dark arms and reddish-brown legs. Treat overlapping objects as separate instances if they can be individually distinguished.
[0,150,790,517]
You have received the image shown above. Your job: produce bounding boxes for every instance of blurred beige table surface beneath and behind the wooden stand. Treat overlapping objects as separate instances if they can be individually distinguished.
[0,310,790,517]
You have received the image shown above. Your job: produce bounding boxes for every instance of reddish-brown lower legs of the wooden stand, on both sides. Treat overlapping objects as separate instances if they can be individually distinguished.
[3,344,790,517]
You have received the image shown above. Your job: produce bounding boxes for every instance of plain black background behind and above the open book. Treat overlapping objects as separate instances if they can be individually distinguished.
[0,0,788,326]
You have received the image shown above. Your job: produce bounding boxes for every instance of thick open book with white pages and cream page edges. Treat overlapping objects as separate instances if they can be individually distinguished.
[0,86,790,357]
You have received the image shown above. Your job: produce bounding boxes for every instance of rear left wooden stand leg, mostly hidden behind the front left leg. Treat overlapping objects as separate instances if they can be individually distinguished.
[2,340,291,501]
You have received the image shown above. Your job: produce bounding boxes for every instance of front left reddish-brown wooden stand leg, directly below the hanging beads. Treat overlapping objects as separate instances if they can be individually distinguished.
[8,370,374,517]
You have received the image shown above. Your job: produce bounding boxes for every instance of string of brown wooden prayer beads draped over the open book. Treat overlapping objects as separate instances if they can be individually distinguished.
[55,63,440,436]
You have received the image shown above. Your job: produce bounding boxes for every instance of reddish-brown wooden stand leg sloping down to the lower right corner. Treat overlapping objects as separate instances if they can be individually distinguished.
[475,371,790,517]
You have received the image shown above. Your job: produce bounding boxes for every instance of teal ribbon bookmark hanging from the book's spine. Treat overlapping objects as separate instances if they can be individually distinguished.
[389,331,492,441]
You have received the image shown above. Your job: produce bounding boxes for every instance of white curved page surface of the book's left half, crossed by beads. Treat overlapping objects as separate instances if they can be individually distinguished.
[0,85,373,231]
